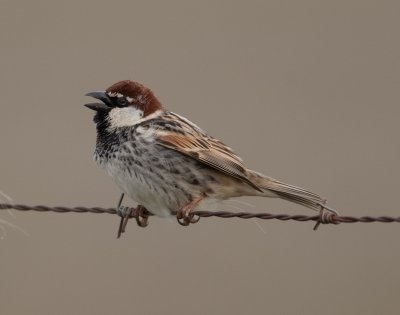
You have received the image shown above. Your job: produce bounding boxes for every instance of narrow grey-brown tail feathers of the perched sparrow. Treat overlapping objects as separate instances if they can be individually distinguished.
[249,171,329,211]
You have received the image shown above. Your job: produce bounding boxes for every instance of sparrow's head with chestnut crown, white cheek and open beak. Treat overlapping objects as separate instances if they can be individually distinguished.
[85,80,162,128]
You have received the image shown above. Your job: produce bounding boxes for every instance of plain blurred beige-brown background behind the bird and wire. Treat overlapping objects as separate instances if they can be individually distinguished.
[0,0,400,315]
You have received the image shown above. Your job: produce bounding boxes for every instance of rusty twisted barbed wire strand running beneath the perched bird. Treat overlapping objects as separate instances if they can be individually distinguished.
[0,203,400,224]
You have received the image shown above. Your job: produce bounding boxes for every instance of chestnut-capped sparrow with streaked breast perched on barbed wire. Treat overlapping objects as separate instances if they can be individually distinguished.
[85,80,336,236]
